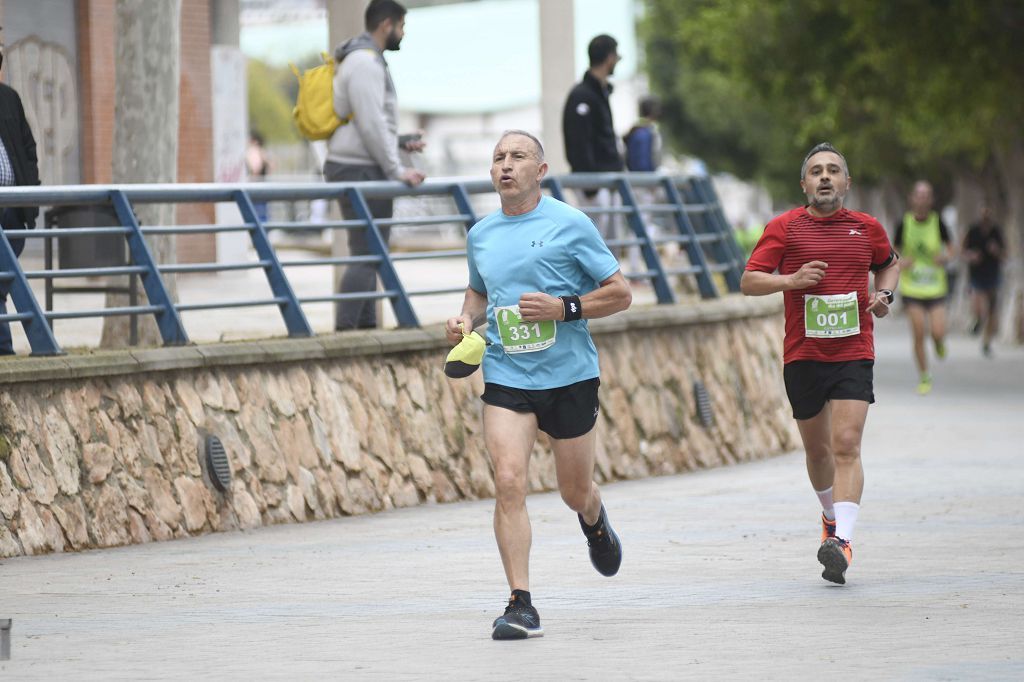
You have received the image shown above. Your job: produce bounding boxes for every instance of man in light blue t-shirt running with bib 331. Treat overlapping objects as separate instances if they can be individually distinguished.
[445,130,632,639]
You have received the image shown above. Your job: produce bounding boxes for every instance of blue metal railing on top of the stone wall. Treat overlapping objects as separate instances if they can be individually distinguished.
[0,173,743,355]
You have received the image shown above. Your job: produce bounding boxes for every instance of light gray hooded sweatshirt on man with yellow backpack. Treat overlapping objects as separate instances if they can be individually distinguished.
[327,33,404,180]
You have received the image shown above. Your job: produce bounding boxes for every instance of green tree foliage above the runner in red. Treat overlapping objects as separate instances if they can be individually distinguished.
[641,0,1024,197]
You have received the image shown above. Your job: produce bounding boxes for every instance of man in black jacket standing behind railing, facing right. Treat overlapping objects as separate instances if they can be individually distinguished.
[562,34,623,240]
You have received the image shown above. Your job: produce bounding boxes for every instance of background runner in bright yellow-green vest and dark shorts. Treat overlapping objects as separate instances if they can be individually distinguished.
[893,180,953,395]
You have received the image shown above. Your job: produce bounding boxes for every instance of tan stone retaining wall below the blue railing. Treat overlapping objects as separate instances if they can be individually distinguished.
[0,297,796,557]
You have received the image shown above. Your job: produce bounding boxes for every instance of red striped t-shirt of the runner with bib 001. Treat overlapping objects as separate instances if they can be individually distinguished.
[746,207,892,364]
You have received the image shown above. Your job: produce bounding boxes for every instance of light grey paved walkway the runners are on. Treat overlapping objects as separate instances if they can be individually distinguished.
[0,319,1024,682]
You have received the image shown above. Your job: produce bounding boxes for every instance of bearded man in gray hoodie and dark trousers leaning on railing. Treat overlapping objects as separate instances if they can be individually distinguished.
[324,0,424,330]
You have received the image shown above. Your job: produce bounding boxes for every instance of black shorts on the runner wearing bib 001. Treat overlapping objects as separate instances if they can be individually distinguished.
[782,360,874,419]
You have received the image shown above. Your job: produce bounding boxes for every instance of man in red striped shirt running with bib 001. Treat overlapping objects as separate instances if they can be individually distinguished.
[740,142,899,585]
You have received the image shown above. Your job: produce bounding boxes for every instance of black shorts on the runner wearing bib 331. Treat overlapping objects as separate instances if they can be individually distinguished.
[480,377,601,439]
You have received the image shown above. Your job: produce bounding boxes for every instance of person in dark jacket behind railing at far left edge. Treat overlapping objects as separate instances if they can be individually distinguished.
[0,48,39,355]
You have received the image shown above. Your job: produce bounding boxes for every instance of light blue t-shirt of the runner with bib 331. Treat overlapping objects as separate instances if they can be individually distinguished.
[466,197,618,390]
